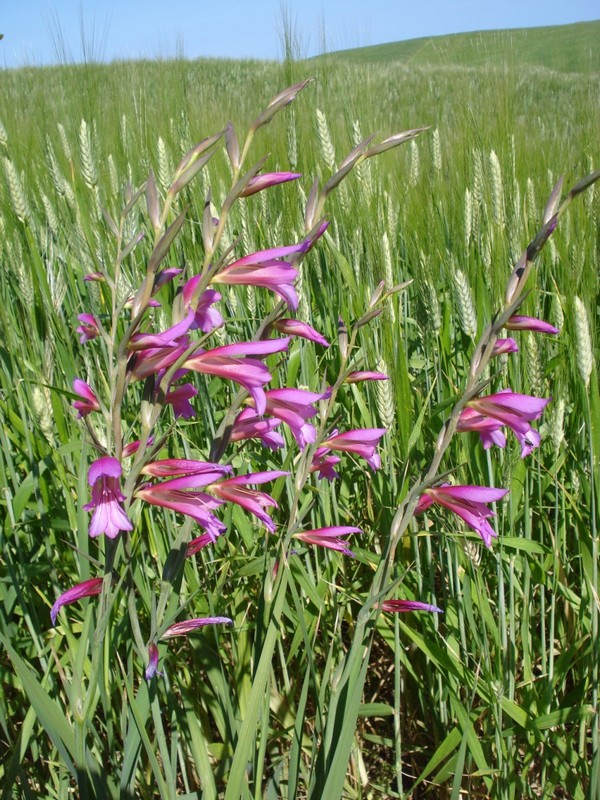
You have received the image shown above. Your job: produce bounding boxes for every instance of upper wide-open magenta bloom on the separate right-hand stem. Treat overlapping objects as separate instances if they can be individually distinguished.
[457,389,552,458]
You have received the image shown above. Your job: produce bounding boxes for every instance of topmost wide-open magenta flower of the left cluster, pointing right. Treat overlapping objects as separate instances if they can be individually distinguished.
[212,240,311,311]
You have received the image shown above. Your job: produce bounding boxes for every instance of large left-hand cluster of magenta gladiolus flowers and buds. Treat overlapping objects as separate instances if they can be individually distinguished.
[52,84,416,679]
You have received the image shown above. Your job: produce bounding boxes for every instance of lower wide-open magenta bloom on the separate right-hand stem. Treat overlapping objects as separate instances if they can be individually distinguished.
[415,484,508,547]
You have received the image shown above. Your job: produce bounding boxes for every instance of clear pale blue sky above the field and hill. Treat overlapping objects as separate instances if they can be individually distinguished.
[0,0,600,67]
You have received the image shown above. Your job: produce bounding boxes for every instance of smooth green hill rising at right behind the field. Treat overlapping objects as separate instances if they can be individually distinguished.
[321,20,600,72]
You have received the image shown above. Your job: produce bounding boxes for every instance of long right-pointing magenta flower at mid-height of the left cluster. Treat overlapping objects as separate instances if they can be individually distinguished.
[183,338,290,414]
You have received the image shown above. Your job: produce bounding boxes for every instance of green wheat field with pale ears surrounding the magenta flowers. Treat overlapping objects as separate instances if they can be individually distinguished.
[0,51,600,799]
